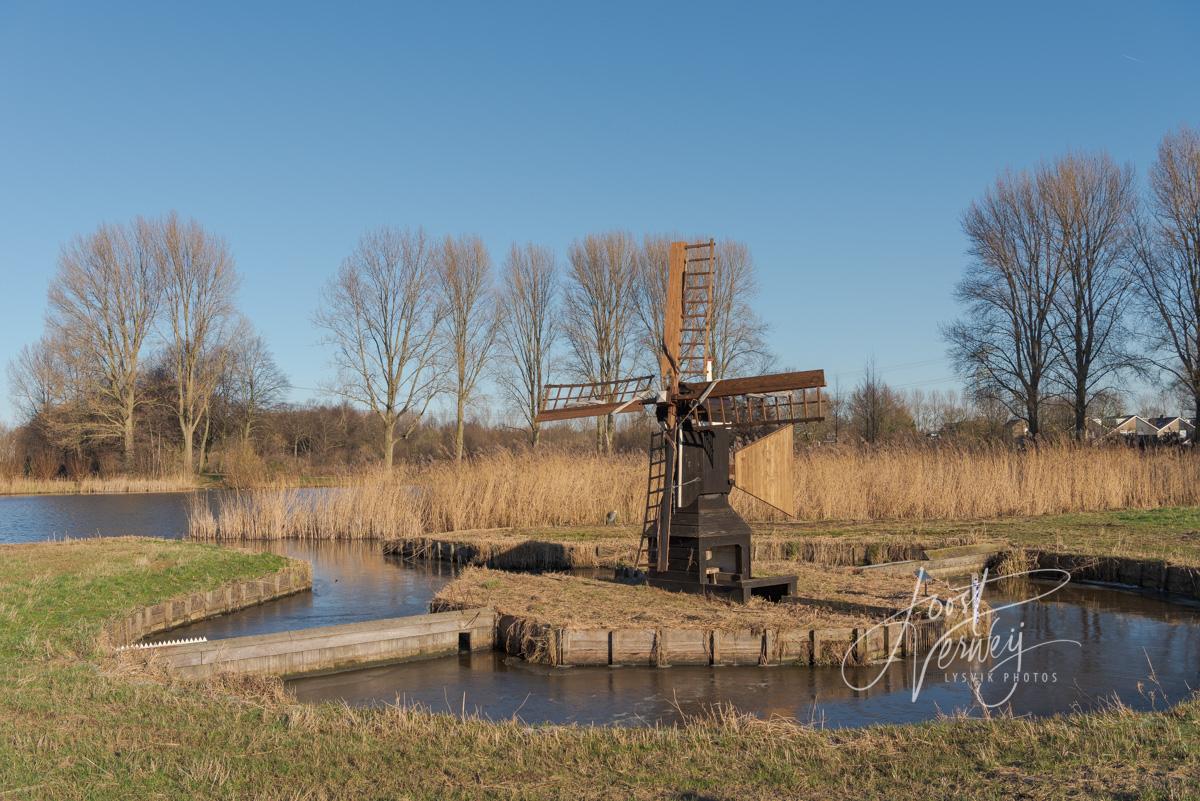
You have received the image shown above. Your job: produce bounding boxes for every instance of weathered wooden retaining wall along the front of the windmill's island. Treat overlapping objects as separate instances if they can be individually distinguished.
[477,615,964,668]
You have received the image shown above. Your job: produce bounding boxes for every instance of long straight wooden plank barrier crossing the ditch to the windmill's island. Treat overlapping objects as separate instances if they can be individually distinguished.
[138,609,496,679]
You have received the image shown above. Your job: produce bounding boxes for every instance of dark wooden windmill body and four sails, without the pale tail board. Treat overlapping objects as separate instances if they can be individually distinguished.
[536,240,826,601]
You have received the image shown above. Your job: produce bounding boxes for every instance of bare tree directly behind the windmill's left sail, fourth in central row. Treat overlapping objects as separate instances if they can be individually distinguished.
[563,231,637,453]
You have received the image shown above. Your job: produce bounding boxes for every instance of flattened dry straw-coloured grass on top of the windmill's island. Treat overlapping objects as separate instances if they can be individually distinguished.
[432,566,926,631]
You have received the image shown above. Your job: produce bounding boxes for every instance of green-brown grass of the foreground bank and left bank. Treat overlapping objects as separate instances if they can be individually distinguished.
[0,540,1200,801]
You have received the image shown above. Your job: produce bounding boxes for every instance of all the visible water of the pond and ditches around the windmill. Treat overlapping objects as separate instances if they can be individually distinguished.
[0,494,1200,727]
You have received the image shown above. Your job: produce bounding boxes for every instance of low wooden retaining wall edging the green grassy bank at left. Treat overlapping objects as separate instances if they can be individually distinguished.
[103,559,312,646]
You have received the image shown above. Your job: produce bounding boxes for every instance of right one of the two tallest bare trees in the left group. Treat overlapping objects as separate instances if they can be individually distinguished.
[156,212,238,472]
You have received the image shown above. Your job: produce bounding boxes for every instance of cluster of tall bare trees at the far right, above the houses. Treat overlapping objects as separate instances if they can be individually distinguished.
[943,127,1200,440]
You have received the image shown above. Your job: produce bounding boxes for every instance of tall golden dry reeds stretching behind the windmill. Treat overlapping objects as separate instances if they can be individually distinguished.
[191,445,1200,540]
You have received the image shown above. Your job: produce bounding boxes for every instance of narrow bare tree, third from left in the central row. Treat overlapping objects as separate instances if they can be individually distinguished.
[497,243,559,447]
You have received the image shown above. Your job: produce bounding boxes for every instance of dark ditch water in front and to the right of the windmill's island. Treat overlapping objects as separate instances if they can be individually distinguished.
[289,577,1200,727]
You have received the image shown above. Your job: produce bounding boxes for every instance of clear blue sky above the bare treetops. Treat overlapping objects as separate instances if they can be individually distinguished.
[0,0,1200,421]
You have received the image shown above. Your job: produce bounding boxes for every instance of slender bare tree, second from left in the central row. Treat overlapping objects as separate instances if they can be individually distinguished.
[437,235,497,462]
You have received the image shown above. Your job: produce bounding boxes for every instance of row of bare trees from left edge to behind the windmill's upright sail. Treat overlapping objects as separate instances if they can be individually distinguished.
[7,224,770,474]
